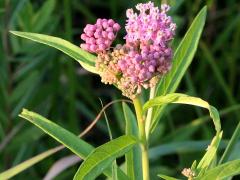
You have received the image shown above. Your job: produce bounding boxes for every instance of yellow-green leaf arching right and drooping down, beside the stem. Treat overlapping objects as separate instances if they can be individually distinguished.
[143,93,222,173]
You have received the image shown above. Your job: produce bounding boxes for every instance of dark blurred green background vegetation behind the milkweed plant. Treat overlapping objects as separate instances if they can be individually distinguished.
[0,0,240,179]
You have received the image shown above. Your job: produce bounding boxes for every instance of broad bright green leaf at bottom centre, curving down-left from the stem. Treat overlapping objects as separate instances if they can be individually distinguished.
[74,135,137,180]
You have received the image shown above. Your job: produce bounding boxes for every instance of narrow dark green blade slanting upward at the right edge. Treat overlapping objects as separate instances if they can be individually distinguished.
[218,122,240,164]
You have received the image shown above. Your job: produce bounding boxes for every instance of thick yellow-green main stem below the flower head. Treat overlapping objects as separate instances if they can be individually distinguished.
[133,98,149,180]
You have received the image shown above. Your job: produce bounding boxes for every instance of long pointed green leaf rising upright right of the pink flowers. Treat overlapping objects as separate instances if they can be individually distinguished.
[151,6,207,132]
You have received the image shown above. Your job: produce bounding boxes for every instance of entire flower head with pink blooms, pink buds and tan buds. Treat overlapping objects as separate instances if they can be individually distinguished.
[81,2,176,99]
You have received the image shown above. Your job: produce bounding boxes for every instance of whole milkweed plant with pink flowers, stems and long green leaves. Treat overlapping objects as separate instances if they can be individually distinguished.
[0,2,240,180]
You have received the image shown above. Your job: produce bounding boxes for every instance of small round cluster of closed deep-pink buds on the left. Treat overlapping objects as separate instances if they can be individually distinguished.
[80,19,120,53]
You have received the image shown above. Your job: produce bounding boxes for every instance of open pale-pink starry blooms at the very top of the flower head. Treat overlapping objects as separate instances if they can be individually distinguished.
[125,2,176,44]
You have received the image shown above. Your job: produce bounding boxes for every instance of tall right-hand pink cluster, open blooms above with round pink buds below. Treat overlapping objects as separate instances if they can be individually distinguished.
[119,2,176,86]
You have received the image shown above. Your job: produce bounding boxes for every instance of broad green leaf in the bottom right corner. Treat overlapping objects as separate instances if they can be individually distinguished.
[196,159,240,180]
